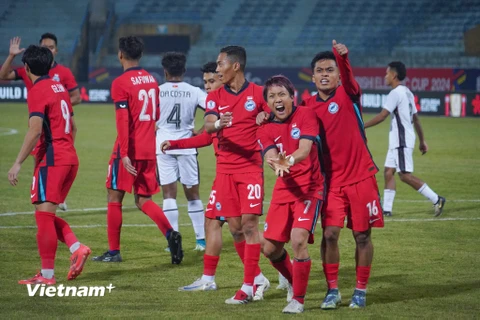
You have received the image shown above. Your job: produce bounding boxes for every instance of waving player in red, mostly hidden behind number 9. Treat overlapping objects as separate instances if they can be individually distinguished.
[0,33,82,211]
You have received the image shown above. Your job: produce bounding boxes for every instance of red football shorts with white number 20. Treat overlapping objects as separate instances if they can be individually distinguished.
[209,172,263,220]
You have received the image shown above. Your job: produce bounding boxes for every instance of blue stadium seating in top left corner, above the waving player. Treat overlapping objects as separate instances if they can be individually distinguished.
[0,0,88,64]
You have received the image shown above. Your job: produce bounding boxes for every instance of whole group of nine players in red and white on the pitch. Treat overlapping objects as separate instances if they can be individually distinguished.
[4,34,445,314]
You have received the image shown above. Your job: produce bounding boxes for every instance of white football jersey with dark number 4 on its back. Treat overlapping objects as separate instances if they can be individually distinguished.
[157,82,207,154]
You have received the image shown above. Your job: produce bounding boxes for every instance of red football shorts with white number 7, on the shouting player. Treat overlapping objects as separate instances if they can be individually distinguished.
[263,197,323,244]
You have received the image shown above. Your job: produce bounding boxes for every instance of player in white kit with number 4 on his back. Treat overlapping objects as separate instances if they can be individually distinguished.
[157,52,207,251]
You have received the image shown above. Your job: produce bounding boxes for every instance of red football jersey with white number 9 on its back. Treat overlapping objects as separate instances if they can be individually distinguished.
[27,76,78,166]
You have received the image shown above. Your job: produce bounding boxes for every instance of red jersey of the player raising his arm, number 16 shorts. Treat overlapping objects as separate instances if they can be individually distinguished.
[302,49,378,187]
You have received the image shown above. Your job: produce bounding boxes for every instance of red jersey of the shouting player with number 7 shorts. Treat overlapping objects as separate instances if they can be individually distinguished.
[257,107,324,203]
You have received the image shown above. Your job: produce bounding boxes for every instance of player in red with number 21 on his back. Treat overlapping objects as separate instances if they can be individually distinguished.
[93,36,183,264]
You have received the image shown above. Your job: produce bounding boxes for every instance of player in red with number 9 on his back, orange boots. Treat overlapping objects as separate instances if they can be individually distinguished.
[8,46,91,285]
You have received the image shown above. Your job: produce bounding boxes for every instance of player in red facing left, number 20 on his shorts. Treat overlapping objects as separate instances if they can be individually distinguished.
[179,46,270,304]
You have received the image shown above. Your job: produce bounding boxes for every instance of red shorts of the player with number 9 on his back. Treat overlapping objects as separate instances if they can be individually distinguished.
[30,165,78,204]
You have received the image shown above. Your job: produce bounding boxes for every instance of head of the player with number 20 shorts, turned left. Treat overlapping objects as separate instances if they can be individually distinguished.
[216,46,247,84]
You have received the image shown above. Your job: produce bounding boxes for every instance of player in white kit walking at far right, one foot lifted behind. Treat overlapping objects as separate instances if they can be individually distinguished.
[365,61,446,217]
